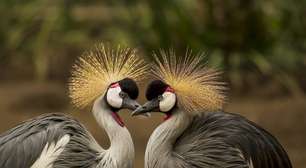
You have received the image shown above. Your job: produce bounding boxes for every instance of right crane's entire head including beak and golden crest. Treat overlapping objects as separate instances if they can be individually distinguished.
[132,50,226,119]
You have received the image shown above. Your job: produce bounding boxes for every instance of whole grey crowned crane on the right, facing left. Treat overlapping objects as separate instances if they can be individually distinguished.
[132,49,292,168]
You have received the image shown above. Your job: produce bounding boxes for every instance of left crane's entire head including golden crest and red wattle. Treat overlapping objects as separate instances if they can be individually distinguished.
[68,44,148,126]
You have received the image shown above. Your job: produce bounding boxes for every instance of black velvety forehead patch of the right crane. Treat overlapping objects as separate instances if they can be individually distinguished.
[146,80,169,100]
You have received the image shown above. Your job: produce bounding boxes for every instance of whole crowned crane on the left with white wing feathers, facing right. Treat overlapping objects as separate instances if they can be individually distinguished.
[0,43,148,168]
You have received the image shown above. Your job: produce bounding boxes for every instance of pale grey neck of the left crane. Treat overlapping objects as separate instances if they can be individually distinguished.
[93,100,134,168]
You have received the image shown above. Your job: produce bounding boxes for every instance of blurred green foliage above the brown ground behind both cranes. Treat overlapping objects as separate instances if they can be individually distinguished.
[0,0,306,93]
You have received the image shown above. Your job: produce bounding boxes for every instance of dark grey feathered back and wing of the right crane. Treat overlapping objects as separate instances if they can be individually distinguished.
[172,112,292,168]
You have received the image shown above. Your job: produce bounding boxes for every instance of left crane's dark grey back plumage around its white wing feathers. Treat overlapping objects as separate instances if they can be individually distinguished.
[0,114,99,168]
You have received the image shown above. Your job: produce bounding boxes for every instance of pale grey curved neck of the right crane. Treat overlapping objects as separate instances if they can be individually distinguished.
[145,109,192,168]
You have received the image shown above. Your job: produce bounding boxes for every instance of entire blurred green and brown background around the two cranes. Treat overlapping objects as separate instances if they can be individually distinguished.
[0,0,306,168]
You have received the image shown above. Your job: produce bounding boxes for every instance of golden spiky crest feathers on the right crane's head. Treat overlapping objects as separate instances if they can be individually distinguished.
[152,50,226,113]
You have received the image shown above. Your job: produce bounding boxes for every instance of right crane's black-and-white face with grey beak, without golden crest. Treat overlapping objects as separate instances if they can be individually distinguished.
[132,80,177,117]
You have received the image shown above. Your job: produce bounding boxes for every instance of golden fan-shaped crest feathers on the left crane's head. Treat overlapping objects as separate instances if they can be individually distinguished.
[68,43,148,108]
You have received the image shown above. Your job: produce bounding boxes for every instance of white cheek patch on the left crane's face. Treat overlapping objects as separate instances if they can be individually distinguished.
[106,87,123,108]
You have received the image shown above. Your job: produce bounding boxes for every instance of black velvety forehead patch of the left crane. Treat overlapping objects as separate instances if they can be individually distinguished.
[118,78,139,99]
